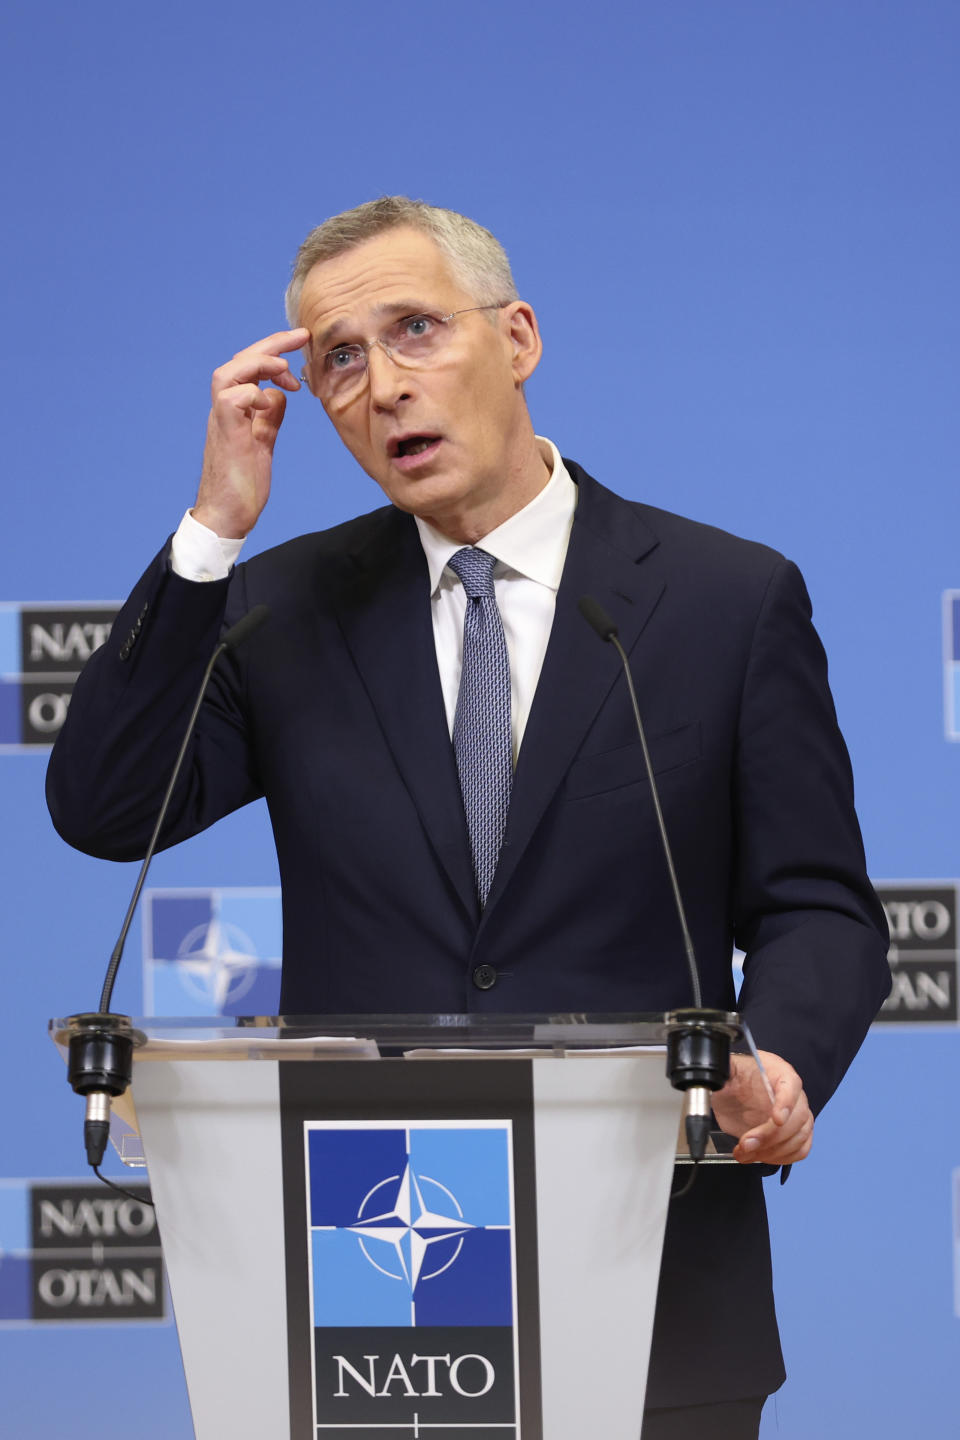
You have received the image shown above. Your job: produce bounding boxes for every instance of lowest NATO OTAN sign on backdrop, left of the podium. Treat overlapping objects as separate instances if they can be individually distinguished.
[0,1179,167,1329]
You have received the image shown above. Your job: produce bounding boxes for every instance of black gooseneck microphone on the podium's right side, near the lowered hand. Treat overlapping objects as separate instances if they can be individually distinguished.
[577,595,735,1164]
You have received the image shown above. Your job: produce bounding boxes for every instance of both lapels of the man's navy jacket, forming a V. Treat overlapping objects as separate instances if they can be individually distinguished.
[326,461,664,927]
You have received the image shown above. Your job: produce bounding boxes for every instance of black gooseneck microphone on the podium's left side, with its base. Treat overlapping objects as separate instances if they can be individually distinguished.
[66,605,271,1175]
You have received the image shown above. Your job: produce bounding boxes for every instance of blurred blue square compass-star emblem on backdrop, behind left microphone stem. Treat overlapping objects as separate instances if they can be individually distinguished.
[142,886,282,1015]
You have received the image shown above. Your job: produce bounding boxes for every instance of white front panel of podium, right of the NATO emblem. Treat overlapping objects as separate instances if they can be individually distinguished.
[534,1051,682,1440]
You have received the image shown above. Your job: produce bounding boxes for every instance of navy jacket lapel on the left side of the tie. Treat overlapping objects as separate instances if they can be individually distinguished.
[335,510,479,919]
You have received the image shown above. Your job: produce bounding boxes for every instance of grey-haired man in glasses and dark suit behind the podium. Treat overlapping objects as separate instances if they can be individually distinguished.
[49,199,888,1440]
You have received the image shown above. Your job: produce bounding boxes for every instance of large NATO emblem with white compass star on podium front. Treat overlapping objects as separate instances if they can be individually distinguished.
[304,1119,520,1440]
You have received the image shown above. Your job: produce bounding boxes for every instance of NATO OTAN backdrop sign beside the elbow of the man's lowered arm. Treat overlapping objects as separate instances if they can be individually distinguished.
[875,880,957,1025]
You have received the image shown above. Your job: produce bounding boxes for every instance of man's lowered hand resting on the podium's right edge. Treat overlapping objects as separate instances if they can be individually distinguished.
[712,1050,813,1165]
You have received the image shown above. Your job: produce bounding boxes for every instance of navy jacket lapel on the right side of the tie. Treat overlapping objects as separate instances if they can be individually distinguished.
[484,472,664,920]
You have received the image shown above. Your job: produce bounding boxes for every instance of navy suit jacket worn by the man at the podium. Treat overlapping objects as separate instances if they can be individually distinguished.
[47,461,888,1404]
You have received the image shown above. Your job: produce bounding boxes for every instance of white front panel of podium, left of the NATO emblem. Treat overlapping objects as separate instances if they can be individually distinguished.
[134,1060,289,1440]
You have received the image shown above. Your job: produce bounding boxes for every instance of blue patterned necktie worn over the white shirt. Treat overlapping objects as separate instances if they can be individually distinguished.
[448,547,514,906]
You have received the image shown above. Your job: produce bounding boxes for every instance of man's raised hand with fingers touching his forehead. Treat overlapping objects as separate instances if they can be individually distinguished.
[193,328,309,540]
